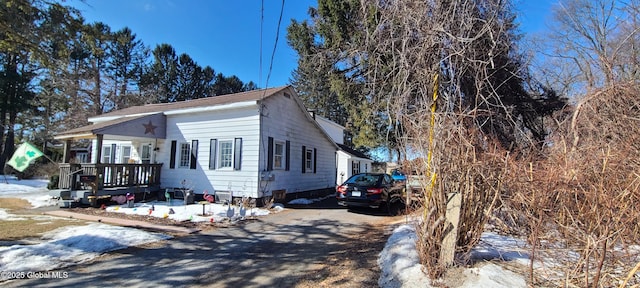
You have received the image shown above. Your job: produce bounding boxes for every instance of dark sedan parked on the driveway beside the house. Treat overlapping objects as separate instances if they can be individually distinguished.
[336,173,404,215]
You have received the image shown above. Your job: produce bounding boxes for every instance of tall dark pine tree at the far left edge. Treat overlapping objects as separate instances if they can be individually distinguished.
[0,0,76,167]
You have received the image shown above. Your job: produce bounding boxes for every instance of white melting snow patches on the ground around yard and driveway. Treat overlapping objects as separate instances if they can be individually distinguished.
[0,176,528,287]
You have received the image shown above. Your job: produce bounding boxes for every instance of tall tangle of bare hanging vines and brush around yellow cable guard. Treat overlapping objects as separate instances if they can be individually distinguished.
[364,1,518,278]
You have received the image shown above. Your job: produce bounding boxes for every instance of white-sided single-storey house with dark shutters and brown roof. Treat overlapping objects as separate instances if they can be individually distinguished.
[56,86,338,202]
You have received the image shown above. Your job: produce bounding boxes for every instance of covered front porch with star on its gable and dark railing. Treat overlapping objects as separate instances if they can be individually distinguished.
[55,113,166,196]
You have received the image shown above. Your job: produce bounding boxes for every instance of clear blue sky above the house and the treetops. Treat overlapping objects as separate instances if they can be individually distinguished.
[66,0,555,87]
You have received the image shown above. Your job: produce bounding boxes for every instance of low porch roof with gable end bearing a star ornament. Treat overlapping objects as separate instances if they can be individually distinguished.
[55,113,167,140]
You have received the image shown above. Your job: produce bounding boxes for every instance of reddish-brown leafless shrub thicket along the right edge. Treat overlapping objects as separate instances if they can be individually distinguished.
[504,83,640,287]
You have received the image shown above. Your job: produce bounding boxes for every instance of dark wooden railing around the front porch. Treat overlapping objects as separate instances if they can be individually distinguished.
[58,163,162,190]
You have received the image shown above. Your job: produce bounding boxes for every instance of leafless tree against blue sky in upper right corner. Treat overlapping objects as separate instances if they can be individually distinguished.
[540,0,640,94]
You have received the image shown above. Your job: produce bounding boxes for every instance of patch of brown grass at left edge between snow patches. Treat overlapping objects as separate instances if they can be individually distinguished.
[0,198,85,241]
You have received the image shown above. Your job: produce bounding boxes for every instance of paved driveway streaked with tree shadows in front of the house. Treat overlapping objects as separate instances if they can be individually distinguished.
[5,199,402,287]
